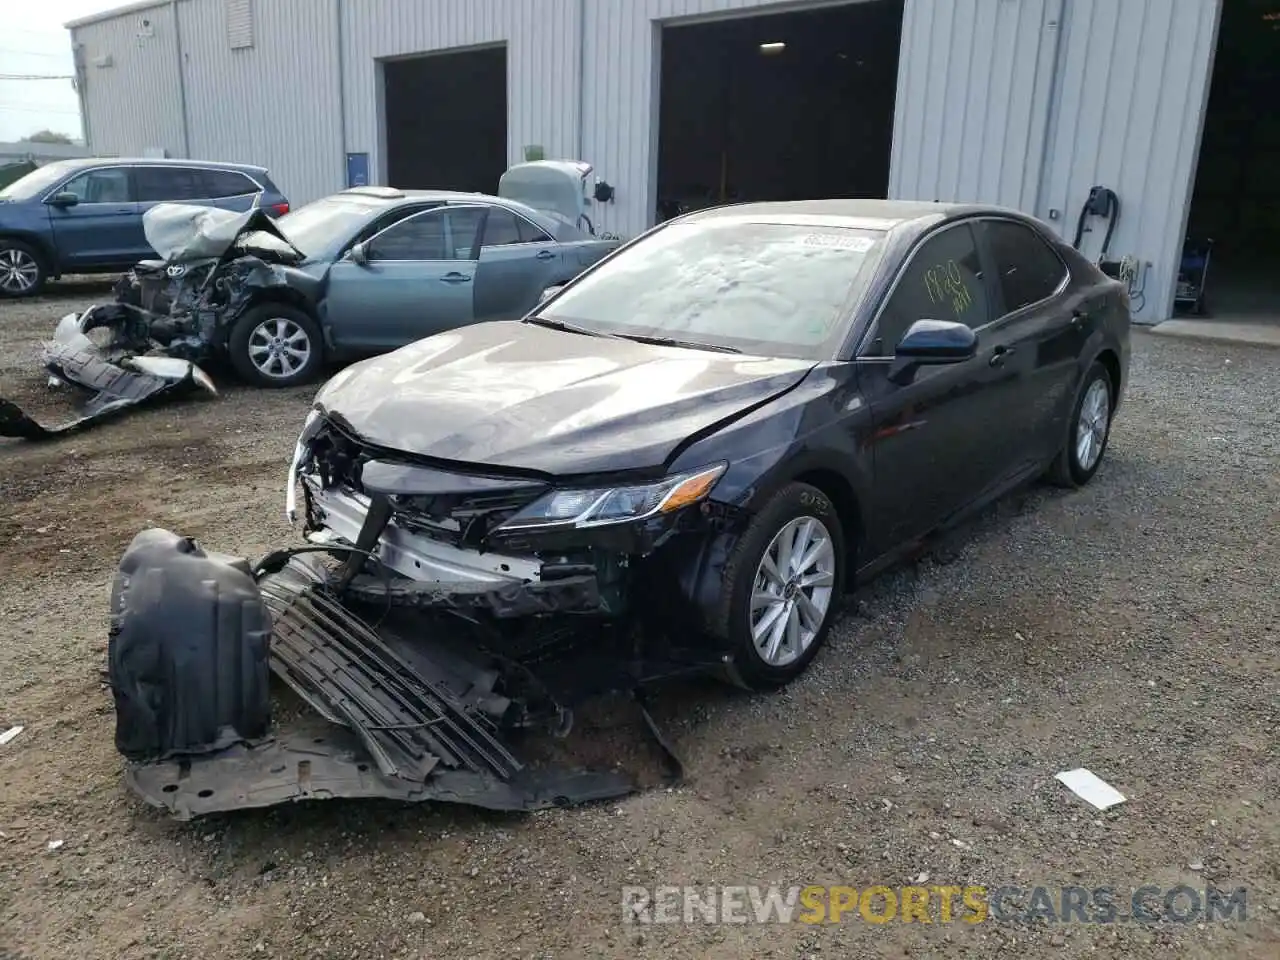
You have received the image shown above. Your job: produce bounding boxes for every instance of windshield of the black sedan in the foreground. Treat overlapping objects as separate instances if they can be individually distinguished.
[538,218,884,360]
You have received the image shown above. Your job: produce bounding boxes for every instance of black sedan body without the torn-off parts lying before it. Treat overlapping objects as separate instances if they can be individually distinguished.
[312,201,1129,684]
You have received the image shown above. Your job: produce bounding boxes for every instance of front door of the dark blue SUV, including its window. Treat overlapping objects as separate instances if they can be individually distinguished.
[49,166,141,271]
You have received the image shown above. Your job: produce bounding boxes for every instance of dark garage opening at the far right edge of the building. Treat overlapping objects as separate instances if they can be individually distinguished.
[1175,0,1280,320]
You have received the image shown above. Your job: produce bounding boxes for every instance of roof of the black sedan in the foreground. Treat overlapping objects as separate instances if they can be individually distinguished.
[681,200,1025,230]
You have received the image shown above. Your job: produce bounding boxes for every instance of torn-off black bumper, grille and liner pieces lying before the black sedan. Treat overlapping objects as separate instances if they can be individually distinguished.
[109,530,680,819]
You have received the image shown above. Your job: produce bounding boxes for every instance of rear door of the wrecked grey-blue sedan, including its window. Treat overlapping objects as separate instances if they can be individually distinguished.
[475,206,563,320]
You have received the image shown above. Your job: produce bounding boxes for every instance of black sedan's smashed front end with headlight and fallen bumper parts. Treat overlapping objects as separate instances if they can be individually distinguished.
[109,411,752,819]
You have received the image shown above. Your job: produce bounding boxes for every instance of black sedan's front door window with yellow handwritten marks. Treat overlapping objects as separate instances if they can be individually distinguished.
[864,223,992,357]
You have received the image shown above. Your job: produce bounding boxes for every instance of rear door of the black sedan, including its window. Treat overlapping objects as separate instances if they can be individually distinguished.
[975,218,1088,471]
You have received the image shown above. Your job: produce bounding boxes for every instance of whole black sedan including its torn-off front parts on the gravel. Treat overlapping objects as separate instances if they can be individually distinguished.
[113,201,1130,815]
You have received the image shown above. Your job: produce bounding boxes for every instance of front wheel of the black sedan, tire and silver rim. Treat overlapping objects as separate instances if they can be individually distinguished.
[710,483,846,690]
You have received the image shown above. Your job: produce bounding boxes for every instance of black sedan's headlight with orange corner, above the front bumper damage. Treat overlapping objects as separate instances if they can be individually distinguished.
[502,463,728,530]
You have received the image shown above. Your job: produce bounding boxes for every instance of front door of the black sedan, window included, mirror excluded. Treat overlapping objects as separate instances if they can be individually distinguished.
[858,221,1011,556]
